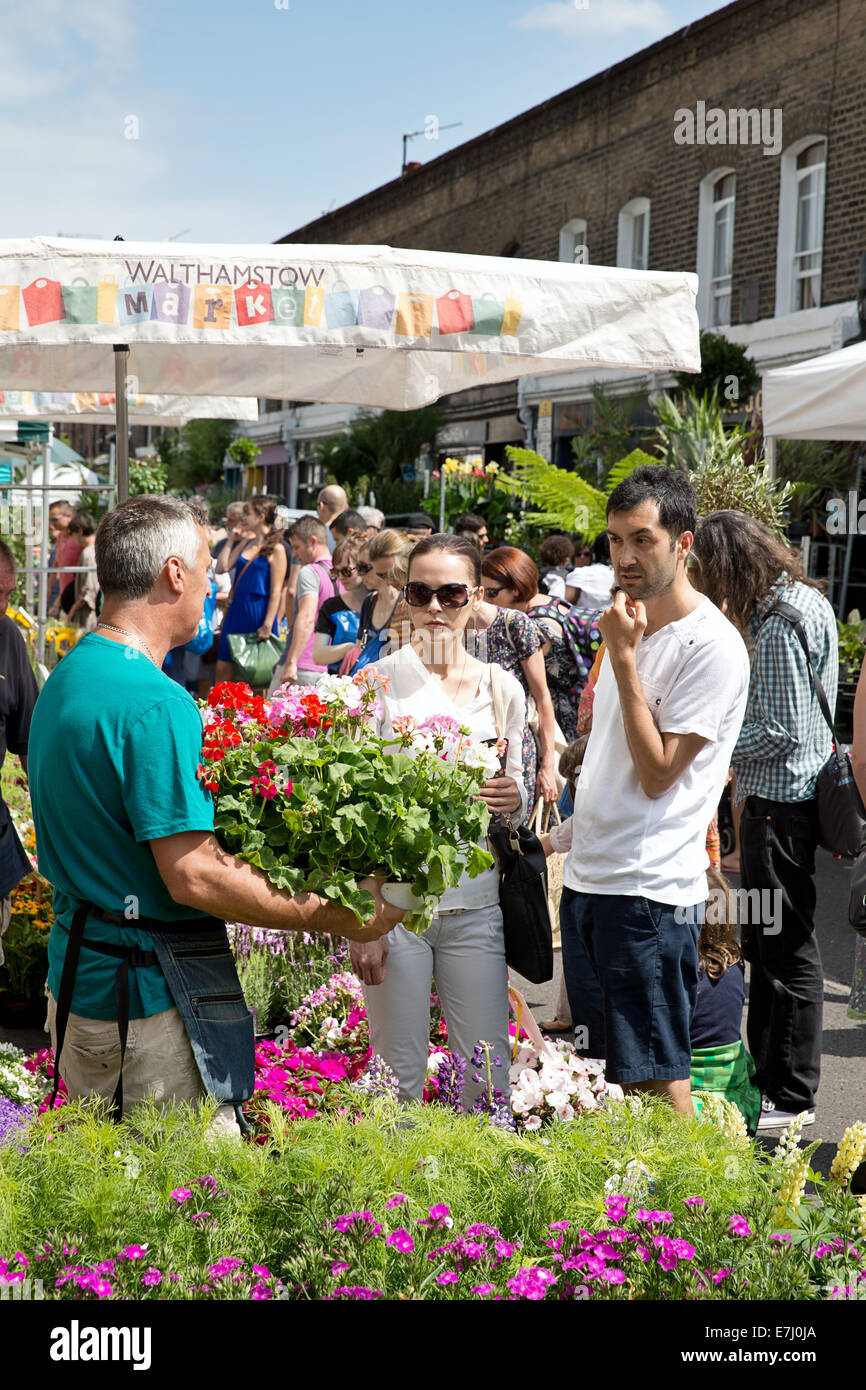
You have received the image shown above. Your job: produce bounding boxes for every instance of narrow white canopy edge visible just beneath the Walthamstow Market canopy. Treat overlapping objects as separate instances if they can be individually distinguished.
[0,391,259,425]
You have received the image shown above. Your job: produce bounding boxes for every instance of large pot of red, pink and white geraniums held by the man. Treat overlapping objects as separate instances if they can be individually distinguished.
[199,666,499,931]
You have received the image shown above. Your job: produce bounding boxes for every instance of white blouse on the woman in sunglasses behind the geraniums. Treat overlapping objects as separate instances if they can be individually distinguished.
[375,645,528,912]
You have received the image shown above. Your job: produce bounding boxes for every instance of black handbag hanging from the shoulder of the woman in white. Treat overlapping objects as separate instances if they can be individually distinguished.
[488,664,553,984]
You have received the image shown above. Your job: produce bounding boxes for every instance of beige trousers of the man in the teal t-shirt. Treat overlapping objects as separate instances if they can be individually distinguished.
[46,991,239,1134]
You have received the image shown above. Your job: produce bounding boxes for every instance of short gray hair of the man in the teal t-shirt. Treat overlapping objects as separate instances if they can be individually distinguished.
[95,496,202,602]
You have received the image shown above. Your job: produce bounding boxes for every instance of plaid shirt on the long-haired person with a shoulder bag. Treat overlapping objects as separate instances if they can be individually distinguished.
[731,574,838,803]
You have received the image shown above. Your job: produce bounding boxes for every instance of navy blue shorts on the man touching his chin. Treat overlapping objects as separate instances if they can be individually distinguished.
[571,892,705,1083]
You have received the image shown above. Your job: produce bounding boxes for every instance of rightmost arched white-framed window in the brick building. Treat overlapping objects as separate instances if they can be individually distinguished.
[776,135,827,314]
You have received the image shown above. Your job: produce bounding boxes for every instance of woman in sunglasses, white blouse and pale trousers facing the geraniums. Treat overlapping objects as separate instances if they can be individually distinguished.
[352,535,527,1108]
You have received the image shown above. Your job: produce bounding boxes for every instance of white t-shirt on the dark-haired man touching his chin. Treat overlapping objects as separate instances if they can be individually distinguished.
[564,598,749,906]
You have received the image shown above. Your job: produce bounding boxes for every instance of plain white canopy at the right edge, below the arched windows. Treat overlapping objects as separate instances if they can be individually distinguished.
[760,342,866,439]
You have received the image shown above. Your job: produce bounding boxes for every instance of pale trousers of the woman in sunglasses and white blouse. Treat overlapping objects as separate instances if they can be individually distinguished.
[364,904,512,1109]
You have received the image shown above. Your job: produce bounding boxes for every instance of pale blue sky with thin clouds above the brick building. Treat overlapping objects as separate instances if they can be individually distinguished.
[0,0,721,242]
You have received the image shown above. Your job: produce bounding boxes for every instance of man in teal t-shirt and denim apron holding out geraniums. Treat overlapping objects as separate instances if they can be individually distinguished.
[29,496,399,1109]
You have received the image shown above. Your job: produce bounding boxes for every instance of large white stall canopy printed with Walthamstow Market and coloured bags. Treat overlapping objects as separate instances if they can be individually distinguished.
[0,238,701,410]
